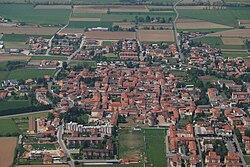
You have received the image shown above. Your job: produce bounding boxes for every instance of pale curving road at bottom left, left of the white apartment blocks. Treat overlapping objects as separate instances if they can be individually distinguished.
[56,125,75,167]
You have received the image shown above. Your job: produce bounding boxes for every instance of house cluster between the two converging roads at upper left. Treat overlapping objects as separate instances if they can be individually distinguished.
[50,33,82,56]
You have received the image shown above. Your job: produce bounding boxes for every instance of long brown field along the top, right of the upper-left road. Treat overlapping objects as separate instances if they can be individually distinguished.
[73,5,148,13]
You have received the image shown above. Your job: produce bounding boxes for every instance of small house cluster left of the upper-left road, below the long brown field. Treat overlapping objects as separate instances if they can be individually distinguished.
[27,37,49,54]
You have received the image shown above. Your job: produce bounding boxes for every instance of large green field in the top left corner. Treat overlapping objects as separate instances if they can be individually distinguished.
[0,4,70,25]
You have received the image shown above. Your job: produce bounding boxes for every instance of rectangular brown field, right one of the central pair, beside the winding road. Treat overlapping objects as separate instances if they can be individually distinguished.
[139,30,174,42]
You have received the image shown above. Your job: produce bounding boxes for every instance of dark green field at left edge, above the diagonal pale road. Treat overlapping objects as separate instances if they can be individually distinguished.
[0,100,30,112]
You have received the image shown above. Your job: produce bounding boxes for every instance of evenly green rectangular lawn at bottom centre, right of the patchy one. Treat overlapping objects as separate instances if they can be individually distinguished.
[145,128,167,167]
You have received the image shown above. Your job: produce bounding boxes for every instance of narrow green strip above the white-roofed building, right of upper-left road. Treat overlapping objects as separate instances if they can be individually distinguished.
[68,21,113,28]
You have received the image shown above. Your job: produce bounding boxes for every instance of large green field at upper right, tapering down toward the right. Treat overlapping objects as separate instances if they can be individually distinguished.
[178,7,250,27]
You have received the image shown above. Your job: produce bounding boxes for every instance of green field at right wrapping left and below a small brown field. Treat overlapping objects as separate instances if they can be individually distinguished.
[193,36,245,49]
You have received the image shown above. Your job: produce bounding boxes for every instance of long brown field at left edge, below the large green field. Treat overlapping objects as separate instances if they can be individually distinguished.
[0,26,59,35]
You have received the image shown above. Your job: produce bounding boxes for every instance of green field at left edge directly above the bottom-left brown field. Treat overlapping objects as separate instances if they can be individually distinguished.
[0,119,19,135]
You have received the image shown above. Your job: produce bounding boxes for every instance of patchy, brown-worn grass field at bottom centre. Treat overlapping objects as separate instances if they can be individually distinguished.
[118,129,145,159]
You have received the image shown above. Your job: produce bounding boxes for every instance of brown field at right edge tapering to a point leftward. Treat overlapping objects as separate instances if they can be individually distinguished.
[210,29,250,38]
